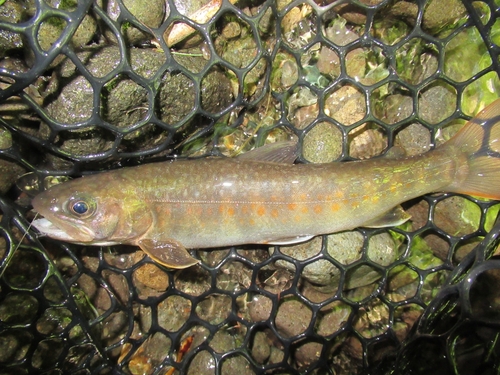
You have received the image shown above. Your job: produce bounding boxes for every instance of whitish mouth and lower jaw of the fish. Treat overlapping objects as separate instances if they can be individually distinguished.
[31,217,95,244]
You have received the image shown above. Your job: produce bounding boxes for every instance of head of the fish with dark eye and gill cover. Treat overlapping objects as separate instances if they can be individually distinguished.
[32,175,152,246]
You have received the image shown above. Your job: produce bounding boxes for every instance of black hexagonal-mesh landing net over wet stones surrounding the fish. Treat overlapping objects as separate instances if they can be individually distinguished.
[0,0,500,374]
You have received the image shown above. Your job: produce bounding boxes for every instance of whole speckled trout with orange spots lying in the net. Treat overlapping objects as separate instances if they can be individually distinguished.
[32,99,500,269]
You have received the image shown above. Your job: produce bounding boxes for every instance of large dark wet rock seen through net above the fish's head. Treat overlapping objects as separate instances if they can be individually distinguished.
[40,47,231,169]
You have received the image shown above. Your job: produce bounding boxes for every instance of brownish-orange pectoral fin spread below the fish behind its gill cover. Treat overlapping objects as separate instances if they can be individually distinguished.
[138,239,199,269]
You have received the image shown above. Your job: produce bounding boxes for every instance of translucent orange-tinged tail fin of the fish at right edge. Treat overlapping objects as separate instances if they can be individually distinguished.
[445,99,500,200]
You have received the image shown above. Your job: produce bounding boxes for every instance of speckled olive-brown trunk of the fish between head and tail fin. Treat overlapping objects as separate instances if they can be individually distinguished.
[71,154,456,248]
